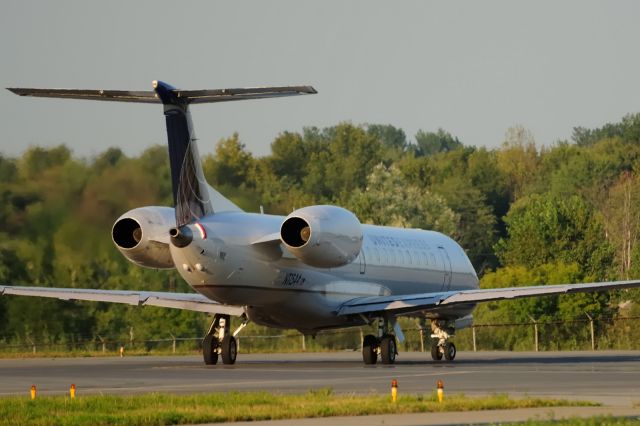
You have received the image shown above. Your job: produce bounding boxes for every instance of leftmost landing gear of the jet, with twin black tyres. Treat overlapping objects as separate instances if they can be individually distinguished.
[202,314,249,365]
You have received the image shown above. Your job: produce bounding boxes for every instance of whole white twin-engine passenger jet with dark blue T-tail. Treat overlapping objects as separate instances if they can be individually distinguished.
[0,81,640,364]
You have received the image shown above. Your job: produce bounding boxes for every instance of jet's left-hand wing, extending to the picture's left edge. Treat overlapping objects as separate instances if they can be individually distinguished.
[0,285,244,316]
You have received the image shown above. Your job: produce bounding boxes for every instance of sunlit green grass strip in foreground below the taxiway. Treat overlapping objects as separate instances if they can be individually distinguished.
[0,388,597,425]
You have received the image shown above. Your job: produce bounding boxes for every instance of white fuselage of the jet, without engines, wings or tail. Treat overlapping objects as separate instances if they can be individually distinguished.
[171,212,478,332]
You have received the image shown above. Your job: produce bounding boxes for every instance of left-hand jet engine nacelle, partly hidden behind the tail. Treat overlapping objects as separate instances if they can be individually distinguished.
[111,206,176,269]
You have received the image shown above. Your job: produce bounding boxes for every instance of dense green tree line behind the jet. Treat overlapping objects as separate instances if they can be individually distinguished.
[0,114,640,348]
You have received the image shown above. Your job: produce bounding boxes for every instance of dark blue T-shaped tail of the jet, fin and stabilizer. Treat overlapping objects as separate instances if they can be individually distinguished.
[9,81,317,227]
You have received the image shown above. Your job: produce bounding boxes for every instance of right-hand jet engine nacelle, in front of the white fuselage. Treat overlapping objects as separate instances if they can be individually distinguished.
[280,206,362,268]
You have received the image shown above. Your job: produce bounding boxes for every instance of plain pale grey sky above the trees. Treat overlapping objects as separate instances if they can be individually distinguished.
[0,0,640,156]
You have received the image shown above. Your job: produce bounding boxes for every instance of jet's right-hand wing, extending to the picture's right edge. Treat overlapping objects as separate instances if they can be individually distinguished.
[338,280,640,315]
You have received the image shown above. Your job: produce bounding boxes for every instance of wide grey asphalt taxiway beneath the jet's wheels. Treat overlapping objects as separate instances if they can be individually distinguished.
[0,351,640,407]
